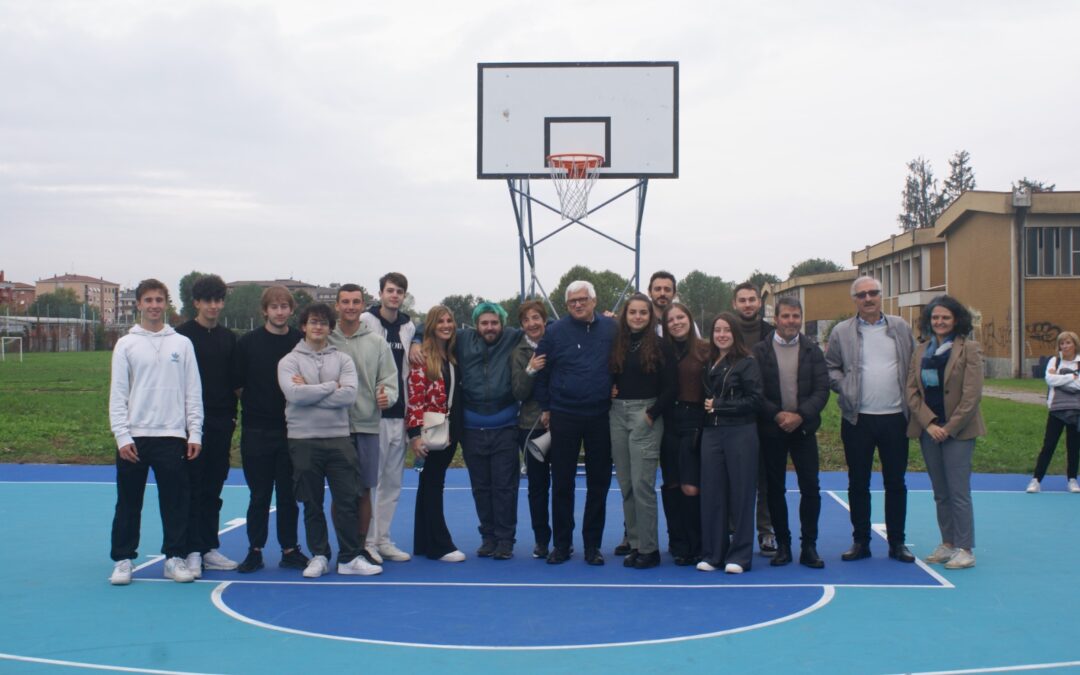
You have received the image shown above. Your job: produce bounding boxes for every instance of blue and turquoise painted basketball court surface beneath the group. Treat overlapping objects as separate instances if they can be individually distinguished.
[0,464,1080,673]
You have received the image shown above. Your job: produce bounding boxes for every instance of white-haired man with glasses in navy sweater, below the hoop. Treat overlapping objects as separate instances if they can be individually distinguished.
[534,281,618,565]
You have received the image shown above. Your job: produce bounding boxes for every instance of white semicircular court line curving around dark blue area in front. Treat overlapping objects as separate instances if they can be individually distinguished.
[211,582,836,651]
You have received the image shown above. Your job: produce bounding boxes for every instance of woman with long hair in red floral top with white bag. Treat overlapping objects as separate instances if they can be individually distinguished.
[405,305,465,563]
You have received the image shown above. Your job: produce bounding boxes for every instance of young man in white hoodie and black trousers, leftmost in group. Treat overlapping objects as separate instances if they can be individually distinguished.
[109,279,203,585]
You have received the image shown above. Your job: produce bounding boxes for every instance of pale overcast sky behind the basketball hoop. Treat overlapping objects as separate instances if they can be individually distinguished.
[0,0,1080,308]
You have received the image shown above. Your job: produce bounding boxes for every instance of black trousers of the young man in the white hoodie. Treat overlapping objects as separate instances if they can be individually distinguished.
[110,436,190,561]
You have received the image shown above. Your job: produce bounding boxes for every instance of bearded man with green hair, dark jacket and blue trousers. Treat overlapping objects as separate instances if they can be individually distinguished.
[455,302,522,561]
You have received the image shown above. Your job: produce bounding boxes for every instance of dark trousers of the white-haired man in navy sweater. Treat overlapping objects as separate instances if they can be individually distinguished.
[549,410,611,551]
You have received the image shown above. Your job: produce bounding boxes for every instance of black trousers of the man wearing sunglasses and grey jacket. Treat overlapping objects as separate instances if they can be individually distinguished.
[840,413,907,544]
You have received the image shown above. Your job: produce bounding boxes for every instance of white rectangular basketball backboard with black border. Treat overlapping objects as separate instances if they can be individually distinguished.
[476,62,678,178]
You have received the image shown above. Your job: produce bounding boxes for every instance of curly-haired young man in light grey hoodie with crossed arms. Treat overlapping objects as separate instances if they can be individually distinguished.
[278,302,382,578]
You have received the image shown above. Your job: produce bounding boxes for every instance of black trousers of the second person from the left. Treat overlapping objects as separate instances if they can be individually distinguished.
[187,417,237,553]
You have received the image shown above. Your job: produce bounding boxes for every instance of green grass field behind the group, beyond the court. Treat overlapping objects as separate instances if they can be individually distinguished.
[0,352,1065,474]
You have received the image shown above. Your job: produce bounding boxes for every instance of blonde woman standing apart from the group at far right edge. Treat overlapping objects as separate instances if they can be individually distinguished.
[1027,330,1080,492]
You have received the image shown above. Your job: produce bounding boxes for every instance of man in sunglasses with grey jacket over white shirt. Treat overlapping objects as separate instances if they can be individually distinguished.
[825,276,915,563]
